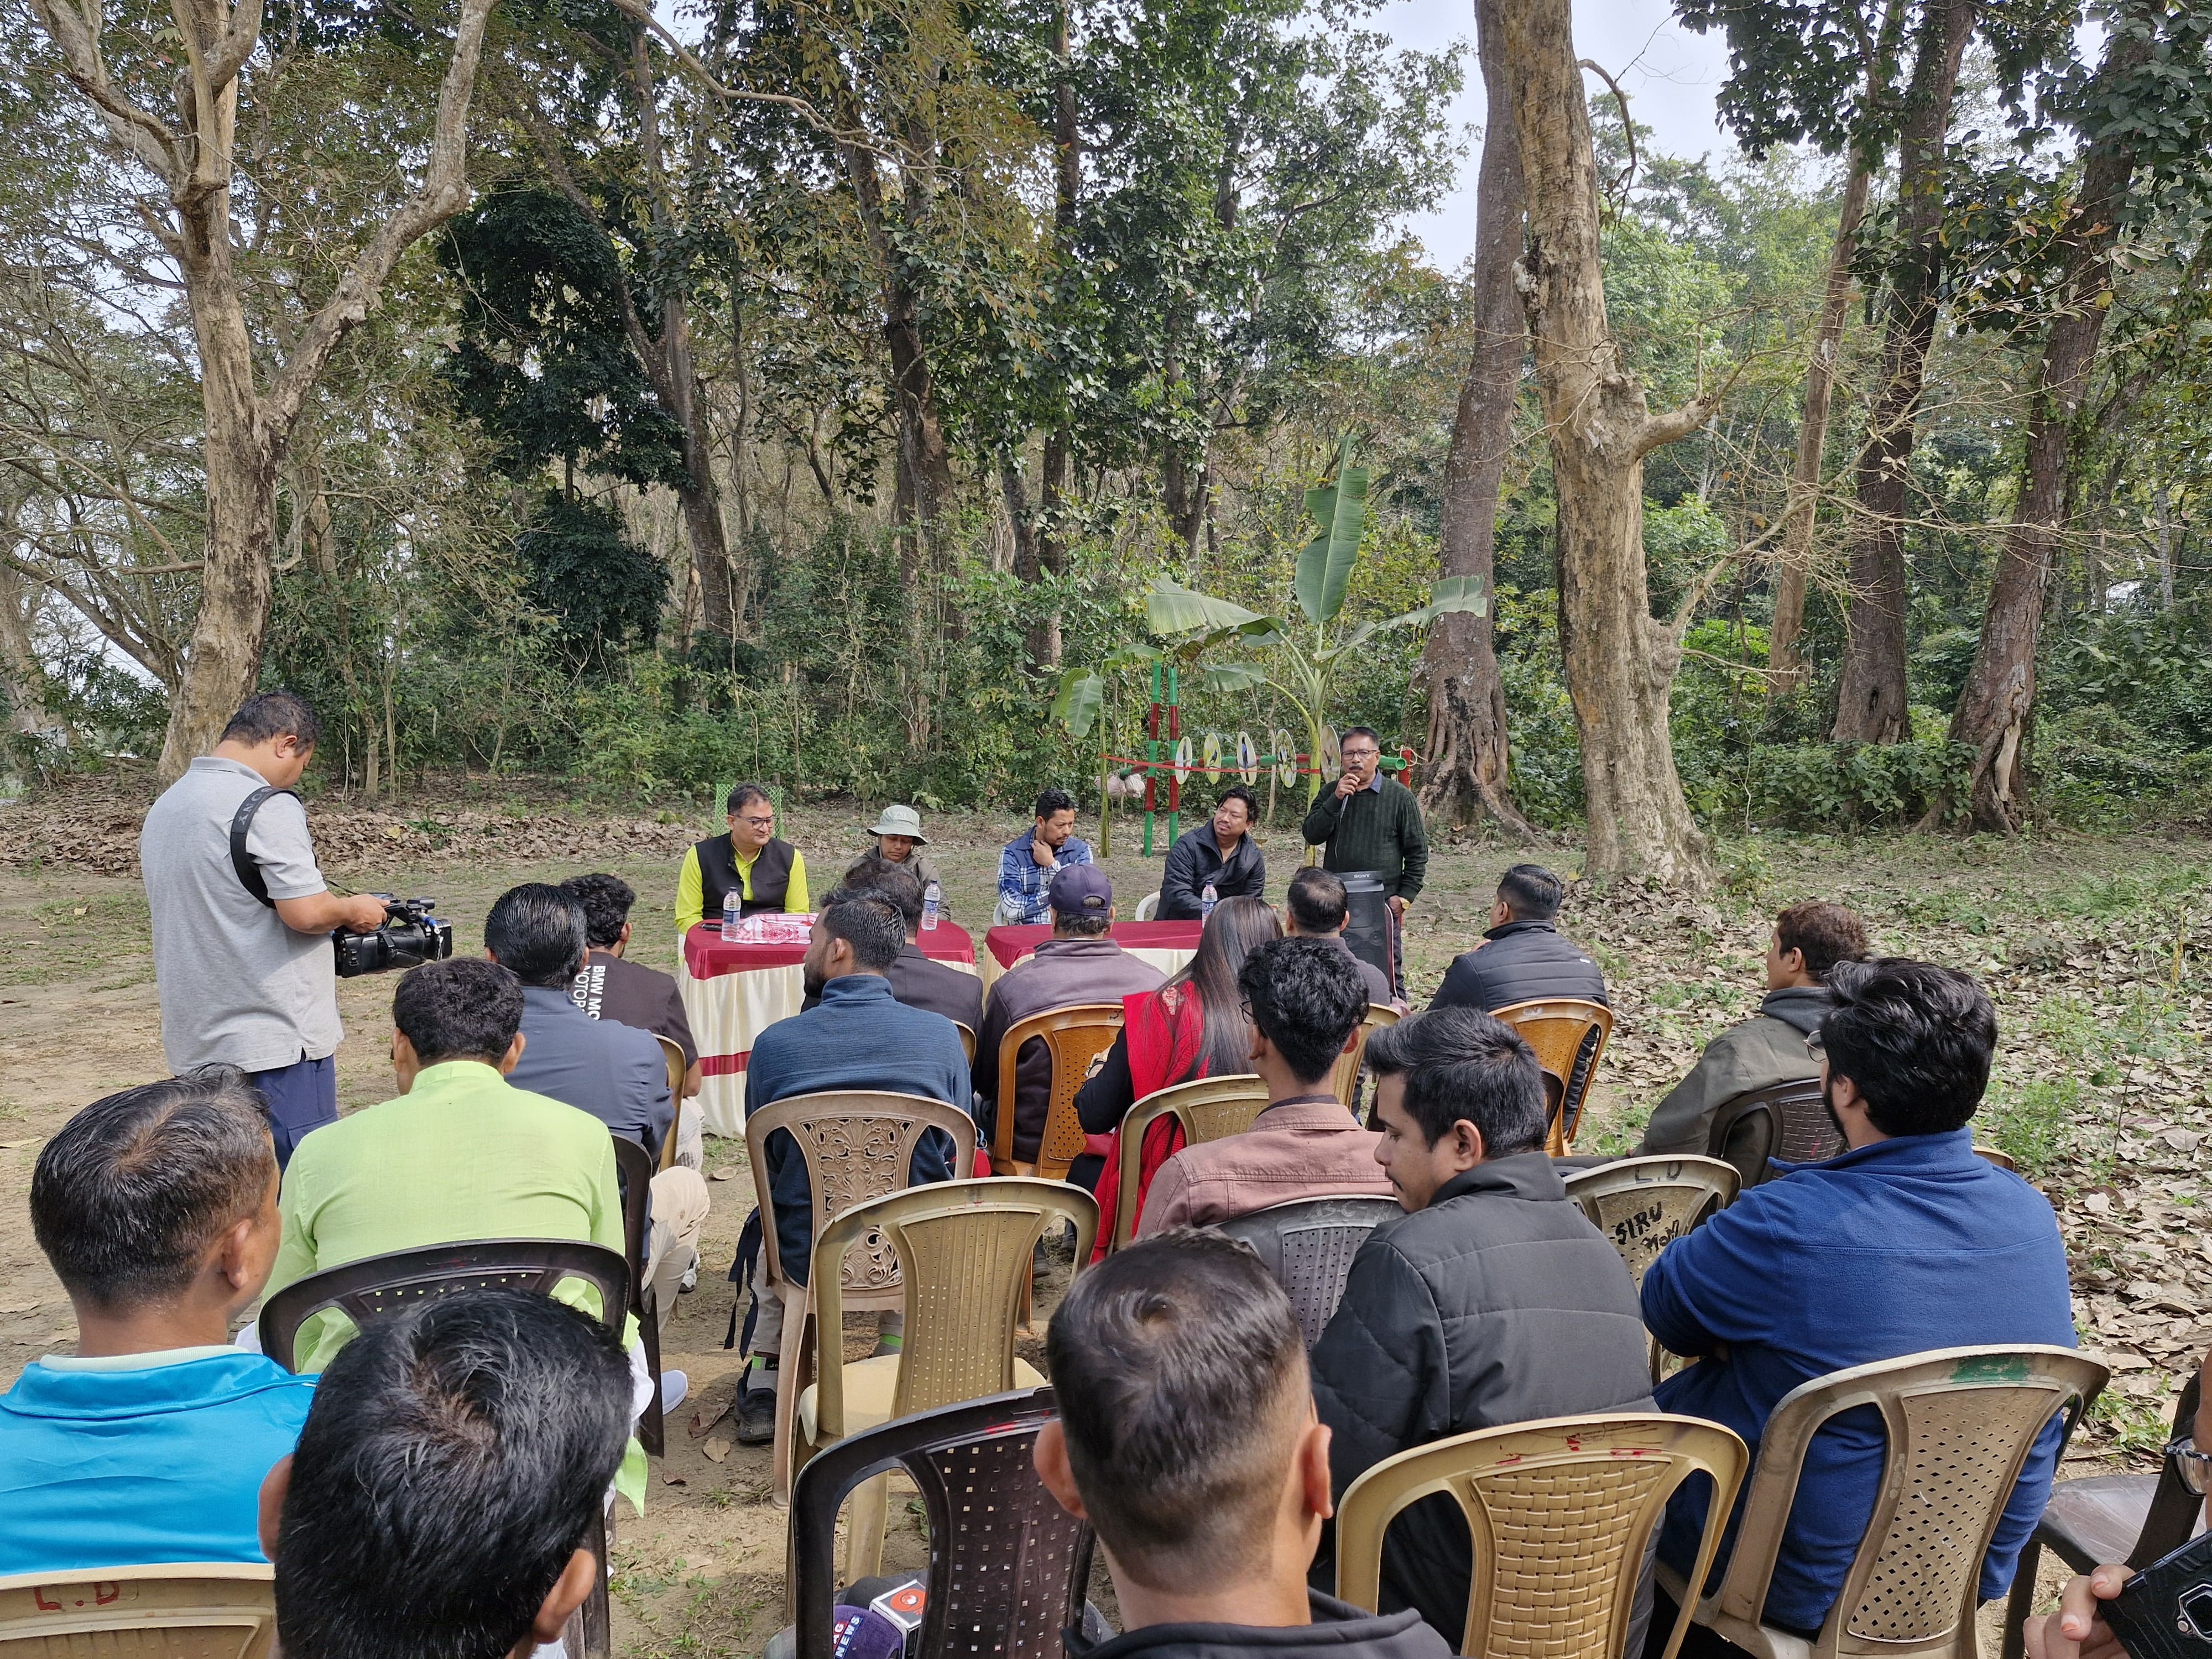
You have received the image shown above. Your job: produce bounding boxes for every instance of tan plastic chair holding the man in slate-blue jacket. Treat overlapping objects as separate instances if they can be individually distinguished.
[745,1091,975,1504]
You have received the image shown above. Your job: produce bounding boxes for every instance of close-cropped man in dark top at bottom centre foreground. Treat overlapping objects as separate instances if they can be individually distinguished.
[1035,1232,1451,1659]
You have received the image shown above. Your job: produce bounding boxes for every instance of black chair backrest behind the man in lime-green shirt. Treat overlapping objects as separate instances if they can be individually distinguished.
[261,1239,630,1371]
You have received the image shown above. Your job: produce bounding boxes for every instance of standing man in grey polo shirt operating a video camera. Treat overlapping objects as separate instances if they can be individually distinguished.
[139,692,385,1166]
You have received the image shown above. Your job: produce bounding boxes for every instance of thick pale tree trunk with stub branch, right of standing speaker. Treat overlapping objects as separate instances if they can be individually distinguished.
[1500,0,1719,887]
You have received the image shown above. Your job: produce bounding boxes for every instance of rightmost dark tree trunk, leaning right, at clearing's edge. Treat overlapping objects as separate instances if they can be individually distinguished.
[1929,31,2150,834]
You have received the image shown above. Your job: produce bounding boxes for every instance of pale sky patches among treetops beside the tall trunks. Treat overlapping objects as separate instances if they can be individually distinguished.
[1376,0,1730,270]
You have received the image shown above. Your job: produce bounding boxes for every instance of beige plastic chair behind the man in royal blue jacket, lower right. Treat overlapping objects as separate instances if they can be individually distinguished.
[1659,1347,2108,1659]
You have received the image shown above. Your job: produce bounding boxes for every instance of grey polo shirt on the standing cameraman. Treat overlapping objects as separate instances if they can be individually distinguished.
[139,754,345,1073]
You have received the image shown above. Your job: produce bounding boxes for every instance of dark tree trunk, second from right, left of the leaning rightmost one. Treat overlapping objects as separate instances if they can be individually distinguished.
[1834,0,1975,743]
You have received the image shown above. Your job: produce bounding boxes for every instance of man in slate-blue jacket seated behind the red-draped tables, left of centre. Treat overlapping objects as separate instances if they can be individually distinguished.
[730,889,969,1447]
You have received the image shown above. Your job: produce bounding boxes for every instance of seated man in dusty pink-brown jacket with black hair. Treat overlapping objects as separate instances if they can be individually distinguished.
[1137,938,1389,1239]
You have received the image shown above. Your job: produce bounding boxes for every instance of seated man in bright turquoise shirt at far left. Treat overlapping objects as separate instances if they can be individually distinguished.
[0,1066,314,1575]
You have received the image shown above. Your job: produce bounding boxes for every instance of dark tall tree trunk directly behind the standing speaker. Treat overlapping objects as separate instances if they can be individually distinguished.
[1420,0,1533,836]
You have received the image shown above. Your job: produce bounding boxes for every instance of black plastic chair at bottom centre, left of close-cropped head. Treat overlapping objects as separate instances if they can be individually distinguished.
[790,1389,1091,1659]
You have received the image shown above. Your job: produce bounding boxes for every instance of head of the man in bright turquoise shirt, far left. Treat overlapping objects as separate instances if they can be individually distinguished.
[31,1066,276,1314]
